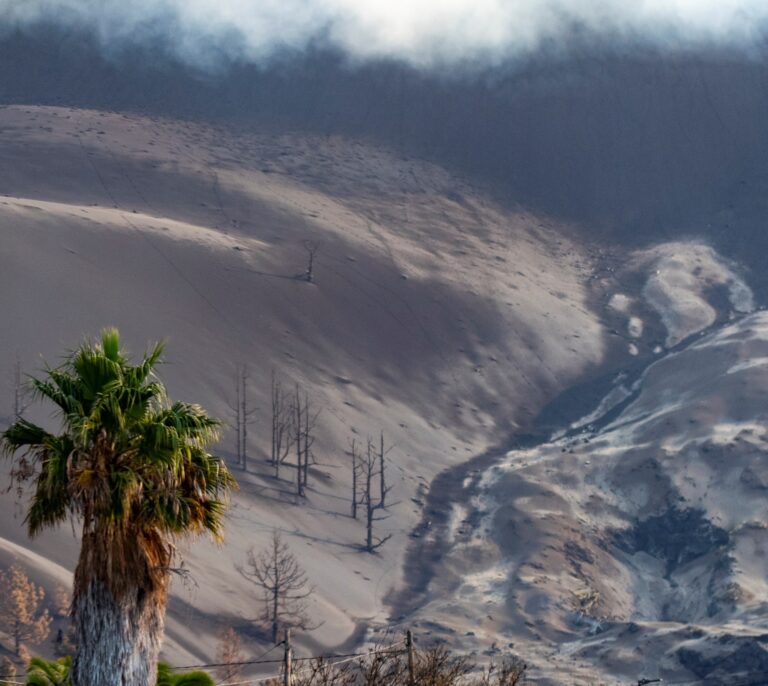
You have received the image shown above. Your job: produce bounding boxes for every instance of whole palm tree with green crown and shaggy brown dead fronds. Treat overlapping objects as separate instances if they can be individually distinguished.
[0,329,236,686]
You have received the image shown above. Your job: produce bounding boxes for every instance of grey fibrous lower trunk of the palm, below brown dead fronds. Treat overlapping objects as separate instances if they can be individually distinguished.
[72,580,165,686]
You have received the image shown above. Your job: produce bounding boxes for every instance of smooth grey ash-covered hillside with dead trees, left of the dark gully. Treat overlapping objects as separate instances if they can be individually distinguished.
[0,106,609,663]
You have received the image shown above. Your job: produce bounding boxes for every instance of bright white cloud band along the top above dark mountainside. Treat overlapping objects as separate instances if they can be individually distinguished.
[0,0,768,67]
